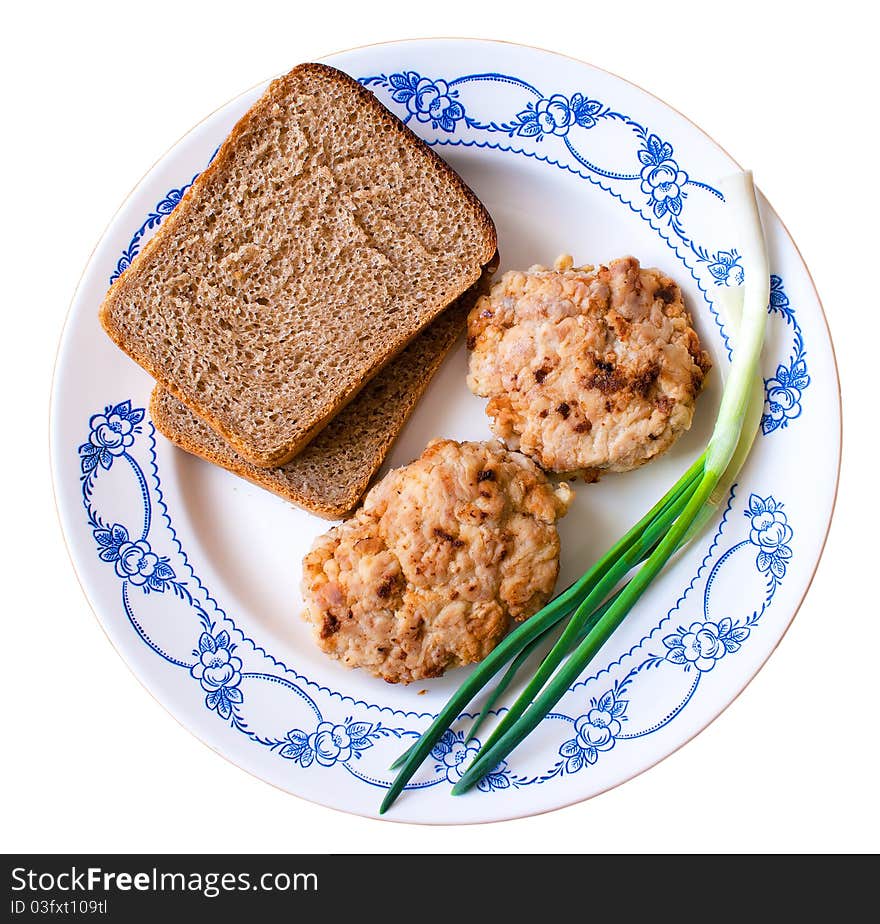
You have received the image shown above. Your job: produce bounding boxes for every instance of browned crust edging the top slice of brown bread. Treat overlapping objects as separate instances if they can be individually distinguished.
[98,63,497,468]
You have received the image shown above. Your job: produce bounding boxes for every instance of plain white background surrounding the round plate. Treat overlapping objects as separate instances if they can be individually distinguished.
[0,0,880,853]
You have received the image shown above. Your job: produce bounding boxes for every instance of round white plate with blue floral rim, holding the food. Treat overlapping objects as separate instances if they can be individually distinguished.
[51,39,840,823]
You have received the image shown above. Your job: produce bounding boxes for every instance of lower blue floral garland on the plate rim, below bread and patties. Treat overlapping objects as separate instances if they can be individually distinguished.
[79,401,794,793]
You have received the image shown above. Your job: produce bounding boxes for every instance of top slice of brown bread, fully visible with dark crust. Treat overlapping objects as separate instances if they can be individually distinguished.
[100,64,496,466]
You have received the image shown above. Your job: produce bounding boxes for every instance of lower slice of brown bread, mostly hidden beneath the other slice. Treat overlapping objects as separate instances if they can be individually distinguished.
[150,271,491,519]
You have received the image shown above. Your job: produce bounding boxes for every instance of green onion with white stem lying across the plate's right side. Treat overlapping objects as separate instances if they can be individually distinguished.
[379,172,770,814]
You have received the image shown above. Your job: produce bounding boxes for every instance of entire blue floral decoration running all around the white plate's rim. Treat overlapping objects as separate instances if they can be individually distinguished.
[77,59,810,808]
